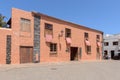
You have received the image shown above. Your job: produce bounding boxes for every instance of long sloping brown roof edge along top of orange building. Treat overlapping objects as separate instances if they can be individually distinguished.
[32,12,103,34]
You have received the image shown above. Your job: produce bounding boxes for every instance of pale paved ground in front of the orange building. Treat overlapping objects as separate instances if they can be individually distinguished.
[0,61,120,80]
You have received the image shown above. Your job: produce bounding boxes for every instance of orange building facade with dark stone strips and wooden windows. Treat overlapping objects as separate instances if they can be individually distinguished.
[0,8,103,64]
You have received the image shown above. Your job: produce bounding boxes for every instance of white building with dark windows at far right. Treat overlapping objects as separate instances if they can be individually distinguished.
[103,34,120,59]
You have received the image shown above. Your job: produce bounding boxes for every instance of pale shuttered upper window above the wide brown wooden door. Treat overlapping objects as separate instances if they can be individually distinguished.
[20,18,31,32]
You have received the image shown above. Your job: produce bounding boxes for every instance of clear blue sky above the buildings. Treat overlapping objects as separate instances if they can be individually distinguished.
[0,0,120,34]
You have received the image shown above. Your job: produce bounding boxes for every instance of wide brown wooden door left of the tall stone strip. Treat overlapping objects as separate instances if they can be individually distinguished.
[20,46,33,63]
